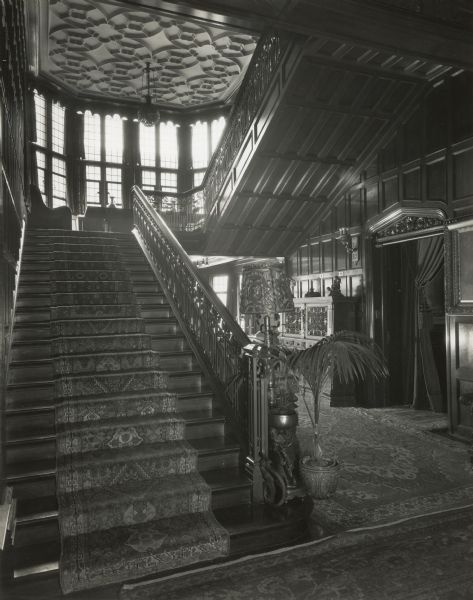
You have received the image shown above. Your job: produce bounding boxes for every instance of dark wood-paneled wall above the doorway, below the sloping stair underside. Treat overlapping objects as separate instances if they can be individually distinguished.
[289,72,473,314]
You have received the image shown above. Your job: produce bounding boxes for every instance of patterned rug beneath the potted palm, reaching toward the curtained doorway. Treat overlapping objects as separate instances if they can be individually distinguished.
[298,405,473,534]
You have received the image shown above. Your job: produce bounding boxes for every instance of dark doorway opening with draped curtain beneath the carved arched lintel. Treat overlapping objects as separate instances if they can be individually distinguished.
[373,237,447,412]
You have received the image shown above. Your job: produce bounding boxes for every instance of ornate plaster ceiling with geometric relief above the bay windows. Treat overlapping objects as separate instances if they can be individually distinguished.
[41,0,257,108]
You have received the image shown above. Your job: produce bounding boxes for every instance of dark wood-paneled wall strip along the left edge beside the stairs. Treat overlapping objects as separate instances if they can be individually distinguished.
[0,0,26,496]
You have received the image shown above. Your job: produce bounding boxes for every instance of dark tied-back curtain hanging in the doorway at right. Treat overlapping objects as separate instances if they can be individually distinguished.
[413,236,444,412]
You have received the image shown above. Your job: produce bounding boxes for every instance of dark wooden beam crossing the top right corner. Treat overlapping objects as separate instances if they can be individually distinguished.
[163,0,473,69]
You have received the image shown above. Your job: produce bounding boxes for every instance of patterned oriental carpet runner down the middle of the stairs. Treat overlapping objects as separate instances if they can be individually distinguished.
[51,236,229,593]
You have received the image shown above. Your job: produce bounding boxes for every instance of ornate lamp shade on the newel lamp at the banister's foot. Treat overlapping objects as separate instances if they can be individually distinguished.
[240,263,294,315]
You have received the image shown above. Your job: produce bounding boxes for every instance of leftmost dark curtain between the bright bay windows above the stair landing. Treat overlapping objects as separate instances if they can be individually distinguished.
[64,108,86,215]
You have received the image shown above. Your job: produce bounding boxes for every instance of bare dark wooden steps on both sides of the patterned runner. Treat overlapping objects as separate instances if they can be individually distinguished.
[6,229,307,592]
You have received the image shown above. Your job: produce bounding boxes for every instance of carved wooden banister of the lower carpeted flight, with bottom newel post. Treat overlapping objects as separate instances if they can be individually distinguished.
[133,186,268,500]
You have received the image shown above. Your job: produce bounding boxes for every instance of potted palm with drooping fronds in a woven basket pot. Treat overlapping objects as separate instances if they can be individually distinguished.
[287,331,388,498]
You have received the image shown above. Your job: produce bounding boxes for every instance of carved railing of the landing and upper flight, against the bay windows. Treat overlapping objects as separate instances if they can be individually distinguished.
[145,32,289,231]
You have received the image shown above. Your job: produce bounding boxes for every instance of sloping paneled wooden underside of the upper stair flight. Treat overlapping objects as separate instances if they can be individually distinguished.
[207,14,472,256]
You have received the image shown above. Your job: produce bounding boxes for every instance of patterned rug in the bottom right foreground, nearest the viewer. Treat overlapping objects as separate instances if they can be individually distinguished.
[121,508,473,600]
